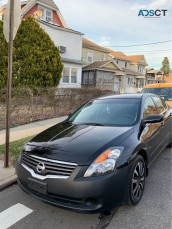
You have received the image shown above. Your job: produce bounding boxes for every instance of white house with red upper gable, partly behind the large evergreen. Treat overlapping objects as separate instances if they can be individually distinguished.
[0,0,83,88]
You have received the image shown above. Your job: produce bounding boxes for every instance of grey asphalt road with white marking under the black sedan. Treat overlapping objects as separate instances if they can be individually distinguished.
[0,148,172,229]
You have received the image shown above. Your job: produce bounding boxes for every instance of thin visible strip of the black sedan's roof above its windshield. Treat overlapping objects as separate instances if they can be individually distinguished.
[97,93,144,99]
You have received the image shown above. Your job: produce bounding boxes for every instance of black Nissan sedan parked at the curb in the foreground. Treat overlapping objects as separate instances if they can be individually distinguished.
[16,94,172,213]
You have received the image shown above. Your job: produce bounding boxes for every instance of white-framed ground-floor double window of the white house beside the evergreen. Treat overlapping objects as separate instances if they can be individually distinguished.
[62,66,78,83]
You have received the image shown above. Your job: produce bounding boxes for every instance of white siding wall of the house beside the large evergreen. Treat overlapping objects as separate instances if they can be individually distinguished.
[39,22,82,88]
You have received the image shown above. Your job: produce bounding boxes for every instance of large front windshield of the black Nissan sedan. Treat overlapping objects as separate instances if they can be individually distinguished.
[67,98,140,126]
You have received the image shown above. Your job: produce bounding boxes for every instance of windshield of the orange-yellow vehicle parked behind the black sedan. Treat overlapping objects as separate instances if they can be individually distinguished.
[142,88,172,101]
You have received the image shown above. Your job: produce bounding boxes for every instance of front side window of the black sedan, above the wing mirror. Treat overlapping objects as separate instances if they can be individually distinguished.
[143,96,158,118]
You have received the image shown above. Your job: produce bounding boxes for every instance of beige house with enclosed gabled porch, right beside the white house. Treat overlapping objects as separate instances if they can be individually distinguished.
[82,38,124,93]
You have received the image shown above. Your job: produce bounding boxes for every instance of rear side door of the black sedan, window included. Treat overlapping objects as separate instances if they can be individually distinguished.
[152,96,171,149]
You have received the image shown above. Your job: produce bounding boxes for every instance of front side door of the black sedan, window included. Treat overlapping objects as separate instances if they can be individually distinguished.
[140,96,163,163]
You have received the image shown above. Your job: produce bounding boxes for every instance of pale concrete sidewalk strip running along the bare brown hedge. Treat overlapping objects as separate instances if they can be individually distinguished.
[0,116,67,145]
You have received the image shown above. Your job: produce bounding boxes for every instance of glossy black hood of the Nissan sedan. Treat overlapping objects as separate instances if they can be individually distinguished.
[24,122,133,165]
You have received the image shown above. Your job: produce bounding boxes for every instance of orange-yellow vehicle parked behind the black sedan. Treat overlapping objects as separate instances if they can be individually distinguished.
[142,83,172,108]
